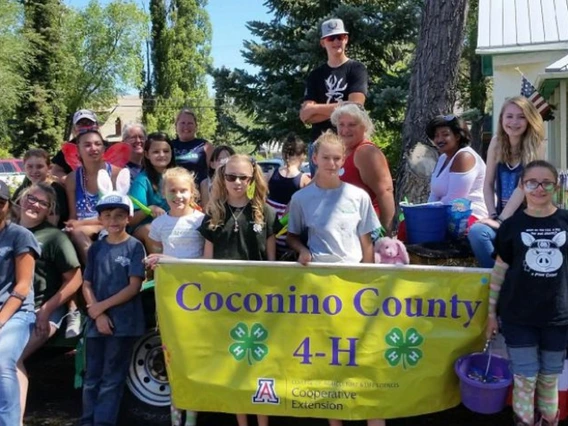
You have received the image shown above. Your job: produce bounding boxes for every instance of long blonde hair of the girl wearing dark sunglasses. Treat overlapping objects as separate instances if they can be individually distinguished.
[206,154,268,230]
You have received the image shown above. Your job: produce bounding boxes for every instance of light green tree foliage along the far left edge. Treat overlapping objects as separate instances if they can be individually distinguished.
[0,0,29,150]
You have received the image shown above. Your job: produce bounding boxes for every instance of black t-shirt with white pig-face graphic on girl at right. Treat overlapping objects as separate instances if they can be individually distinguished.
[495,209,568,326]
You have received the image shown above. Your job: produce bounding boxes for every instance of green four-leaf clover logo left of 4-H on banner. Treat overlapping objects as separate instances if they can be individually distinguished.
[229,322,268,365]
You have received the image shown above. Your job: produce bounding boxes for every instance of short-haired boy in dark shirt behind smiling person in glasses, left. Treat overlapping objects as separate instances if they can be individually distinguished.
[12,148,69,229]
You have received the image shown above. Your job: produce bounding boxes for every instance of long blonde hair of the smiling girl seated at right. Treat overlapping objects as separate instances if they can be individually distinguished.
[497,96,544,166]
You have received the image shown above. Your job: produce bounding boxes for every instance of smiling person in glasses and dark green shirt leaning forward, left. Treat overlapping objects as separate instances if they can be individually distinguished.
[15,182,82,424]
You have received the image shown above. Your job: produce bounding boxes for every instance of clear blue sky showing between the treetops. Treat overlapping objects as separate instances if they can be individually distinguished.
[64,0,269,72]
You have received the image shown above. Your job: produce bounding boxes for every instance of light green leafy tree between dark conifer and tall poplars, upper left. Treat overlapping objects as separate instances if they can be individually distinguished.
[62,0,148,135]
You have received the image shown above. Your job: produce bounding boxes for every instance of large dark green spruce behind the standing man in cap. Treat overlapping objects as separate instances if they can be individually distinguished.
[214,0,420,155]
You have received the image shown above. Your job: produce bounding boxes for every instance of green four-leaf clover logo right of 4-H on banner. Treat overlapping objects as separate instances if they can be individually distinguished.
[385,328,424,370]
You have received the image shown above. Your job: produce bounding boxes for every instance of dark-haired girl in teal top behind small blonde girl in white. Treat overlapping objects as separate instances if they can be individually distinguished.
[129,132,175,253]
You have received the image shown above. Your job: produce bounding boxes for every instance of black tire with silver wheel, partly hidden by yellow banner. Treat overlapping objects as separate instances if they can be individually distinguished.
[120,331,171,426]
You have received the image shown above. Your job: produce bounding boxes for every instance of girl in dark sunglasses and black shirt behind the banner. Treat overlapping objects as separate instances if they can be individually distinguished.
[199,154,279,426]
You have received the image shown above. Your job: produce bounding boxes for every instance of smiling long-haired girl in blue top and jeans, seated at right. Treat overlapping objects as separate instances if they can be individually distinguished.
[468,96,544,268]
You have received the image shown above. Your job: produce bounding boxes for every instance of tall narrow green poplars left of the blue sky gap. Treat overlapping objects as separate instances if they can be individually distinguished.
[143,0,216,137]
